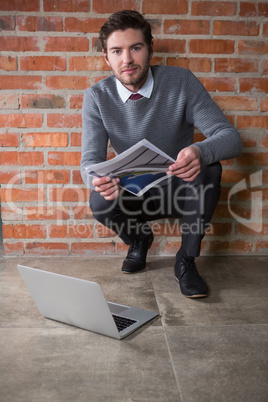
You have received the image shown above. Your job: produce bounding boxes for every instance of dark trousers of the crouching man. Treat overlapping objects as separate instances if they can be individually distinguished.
[90,162,222,257]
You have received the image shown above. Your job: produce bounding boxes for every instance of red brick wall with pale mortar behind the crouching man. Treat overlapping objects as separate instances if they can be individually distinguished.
[0,0,268,255]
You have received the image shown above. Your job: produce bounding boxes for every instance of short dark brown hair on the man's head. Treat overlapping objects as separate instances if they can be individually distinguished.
[99,10,153,54]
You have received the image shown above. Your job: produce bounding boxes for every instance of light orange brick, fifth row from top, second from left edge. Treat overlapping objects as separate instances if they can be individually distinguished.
[45,76,90,90]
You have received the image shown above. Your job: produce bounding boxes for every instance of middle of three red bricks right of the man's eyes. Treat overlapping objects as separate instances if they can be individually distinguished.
[190,39,234,54]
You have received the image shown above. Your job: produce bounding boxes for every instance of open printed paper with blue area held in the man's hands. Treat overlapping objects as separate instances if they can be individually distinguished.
[85,140,175,197]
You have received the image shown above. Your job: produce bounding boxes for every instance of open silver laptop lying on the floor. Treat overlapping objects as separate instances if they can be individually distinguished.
[18,265,158,339]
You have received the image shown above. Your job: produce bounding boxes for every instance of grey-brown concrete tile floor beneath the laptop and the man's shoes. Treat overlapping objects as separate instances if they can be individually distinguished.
[0,256,268,402]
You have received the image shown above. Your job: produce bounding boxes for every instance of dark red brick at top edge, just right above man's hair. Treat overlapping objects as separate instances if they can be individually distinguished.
[143,0,188,14]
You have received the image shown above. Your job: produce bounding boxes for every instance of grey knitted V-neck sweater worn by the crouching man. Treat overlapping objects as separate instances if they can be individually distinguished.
[81,66,242,188]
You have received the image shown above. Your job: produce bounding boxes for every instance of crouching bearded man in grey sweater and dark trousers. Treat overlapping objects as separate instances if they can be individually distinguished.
[81,11,242,298]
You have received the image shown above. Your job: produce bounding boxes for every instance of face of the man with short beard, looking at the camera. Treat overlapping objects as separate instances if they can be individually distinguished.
[104,28,152,92]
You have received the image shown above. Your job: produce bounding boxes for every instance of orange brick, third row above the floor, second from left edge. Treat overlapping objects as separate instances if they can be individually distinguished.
[23,206,69,221]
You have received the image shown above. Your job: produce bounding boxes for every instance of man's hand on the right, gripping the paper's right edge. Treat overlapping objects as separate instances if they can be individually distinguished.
[167,147,201,181]
